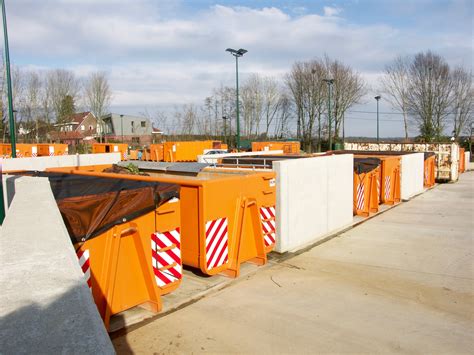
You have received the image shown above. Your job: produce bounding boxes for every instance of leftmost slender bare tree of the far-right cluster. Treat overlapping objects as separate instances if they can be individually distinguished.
[381,56,410,139]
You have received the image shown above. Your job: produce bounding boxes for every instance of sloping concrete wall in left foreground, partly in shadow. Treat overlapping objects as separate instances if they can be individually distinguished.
[0,177,114,354]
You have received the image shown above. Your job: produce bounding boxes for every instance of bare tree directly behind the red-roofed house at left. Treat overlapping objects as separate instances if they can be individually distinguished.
[46,69,80,123]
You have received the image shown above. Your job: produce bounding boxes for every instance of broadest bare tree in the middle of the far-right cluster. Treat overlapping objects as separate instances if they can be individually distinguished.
[408,51,453,141]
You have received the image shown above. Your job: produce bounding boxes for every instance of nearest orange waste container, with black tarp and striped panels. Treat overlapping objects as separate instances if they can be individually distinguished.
[30,172,182,329]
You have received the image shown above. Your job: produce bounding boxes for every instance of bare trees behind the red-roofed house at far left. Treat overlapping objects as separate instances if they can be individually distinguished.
[0,60,112,141]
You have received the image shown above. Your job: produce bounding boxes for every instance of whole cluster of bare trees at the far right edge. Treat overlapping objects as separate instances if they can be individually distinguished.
[382,52,474,141]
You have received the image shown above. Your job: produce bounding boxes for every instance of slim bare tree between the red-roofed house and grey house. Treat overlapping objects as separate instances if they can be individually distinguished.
[84,71,112,142]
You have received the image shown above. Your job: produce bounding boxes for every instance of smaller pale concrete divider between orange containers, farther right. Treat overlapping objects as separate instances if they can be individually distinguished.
[400,153,424,200]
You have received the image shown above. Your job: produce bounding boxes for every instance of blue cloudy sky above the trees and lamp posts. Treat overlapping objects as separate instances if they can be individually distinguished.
[1,0,473,136]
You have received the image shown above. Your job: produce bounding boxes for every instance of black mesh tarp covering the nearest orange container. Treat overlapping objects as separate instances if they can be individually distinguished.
[17,172,179,244]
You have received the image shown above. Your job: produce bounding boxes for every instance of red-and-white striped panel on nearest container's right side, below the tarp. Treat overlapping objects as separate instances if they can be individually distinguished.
[151,228,183,287]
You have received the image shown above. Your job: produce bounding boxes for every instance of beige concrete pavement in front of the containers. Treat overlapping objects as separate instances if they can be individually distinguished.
[114,172,474,353]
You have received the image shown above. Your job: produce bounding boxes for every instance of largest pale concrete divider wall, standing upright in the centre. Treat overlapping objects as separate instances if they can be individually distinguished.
[273,154,354,253]
